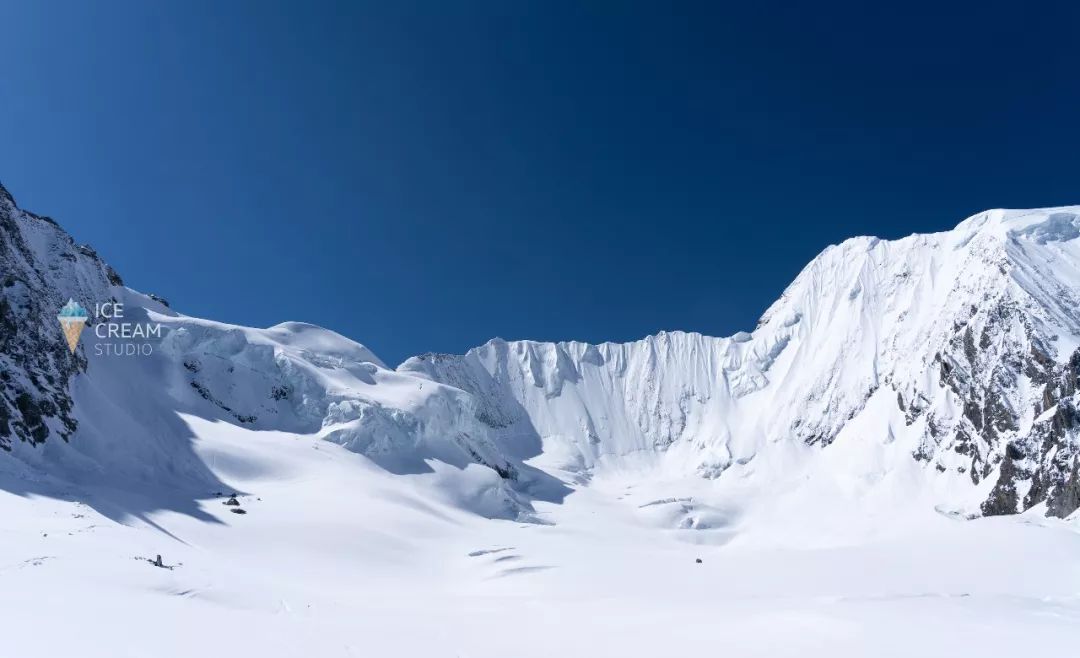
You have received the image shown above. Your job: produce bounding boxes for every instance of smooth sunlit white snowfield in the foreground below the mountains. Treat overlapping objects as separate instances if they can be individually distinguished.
[0,416,1080,658]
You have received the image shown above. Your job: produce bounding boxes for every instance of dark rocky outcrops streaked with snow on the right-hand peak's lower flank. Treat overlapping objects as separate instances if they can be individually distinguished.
[911,285,1080,518]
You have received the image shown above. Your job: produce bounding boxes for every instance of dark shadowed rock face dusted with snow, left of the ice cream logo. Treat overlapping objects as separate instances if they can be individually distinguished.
[0,182,120,451]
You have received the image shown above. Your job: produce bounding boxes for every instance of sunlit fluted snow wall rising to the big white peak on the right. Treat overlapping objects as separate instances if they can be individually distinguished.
[399,207,1080,516]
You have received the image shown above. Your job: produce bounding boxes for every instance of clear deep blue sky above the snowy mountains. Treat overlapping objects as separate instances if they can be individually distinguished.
[0,0,1080,363]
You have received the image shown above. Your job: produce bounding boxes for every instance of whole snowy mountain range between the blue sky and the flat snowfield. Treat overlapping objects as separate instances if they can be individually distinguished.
[0,178,1080,519]
